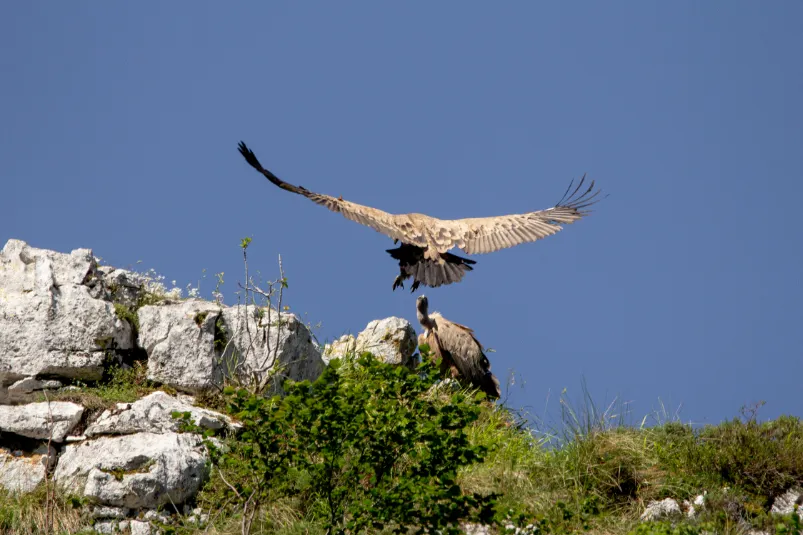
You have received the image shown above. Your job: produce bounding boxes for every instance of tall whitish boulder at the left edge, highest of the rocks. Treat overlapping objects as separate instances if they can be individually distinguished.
[0,240,133,390]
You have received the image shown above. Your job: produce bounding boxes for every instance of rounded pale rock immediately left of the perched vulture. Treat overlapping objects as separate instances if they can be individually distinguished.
[356,317,418,365]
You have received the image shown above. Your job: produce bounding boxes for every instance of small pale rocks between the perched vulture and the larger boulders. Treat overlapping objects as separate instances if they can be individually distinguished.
[324,317,418,366]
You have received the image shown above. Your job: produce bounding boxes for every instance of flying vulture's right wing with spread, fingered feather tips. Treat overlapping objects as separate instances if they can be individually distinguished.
[436,175,600,254]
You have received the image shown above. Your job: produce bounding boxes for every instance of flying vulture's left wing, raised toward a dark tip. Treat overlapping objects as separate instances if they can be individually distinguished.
[239,141,427,247]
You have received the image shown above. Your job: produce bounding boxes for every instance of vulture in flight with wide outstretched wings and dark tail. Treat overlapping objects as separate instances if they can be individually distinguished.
[239,141,600,291]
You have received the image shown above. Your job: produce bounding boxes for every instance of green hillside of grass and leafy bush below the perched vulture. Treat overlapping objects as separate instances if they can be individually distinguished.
[0,355,803,534]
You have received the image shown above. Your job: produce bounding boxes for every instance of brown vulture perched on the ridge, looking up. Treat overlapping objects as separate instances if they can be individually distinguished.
[415,295,500,399]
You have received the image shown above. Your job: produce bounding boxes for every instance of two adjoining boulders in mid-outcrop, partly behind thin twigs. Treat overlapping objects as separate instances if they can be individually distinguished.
[139,299,324,393]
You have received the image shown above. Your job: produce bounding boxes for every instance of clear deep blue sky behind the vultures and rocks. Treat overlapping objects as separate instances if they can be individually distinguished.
[0,0,803,423]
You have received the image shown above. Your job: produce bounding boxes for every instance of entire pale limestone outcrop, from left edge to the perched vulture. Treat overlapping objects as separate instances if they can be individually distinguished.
[0,240,424,533]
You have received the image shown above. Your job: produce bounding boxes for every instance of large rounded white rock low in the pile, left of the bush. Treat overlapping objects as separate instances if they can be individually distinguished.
[53,433,208,509]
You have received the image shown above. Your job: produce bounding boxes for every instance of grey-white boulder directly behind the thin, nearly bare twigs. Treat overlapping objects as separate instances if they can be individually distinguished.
[221,306,324,394]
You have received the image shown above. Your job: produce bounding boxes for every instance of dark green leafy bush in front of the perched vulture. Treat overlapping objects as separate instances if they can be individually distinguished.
[201,354,495,533]
